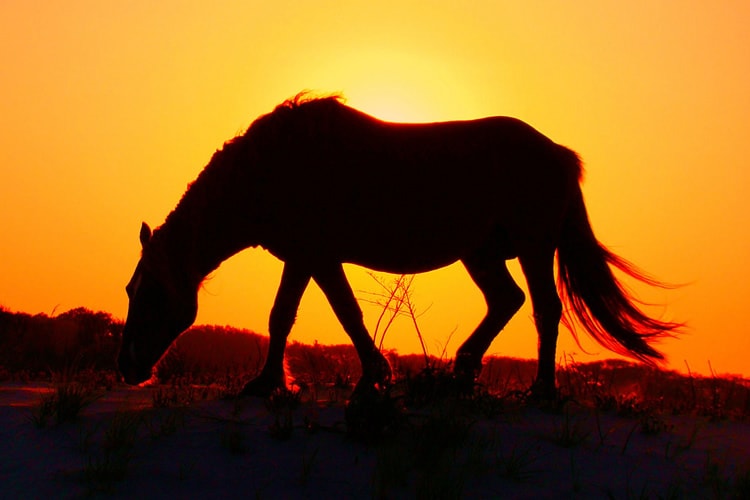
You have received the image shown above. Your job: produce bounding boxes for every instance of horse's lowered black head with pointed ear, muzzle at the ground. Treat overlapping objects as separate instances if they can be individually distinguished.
[117,223,198,384]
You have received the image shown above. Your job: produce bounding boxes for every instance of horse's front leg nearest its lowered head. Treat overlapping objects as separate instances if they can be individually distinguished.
[240,263,310,397]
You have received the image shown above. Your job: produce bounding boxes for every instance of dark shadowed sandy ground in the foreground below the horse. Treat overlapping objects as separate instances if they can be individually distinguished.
[0,383,750,499]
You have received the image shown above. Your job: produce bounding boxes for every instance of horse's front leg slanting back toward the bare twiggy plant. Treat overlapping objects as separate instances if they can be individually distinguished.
[313,264,391,389]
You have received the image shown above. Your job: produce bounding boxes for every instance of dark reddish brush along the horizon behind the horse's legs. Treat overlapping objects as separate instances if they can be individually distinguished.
[0,308,750,420]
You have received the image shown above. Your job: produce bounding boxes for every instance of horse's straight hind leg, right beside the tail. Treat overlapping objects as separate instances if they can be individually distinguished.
[518,249,562,399]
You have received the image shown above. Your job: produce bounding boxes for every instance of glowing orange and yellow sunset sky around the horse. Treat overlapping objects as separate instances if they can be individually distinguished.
[0,0,750,376]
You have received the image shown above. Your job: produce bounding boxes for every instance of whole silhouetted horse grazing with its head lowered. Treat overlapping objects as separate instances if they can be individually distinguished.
[118,94,680,397]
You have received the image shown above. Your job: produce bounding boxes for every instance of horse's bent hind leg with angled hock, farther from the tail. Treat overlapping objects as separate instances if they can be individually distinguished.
[454,249,524,384]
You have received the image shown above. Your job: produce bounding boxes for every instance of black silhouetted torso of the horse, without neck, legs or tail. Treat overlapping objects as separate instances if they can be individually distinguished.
[253,99,572,272]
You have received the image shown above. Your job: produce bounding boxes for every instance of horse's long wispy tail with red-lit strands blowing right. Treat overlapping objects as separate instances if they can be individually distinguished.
[557,175,682,363]
